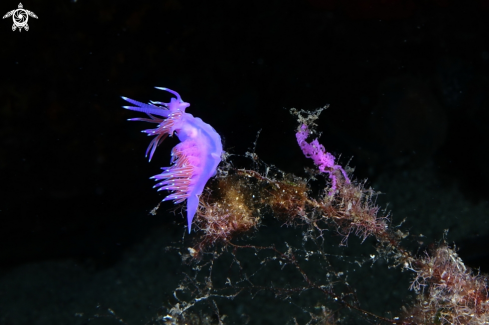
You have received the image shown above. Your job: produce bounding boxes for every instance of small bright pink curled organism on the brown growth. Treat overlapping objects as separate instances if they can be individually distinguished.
[295,124,350,196]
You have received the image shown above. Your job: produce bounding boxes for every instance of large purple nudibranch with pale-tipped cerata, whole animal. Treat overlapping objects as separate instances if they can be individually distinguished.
[122,87,223,233]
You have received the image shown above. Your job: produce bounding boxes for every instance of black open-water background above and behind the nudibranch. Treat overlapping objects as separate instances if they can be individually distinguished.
[0,0,489,324]
